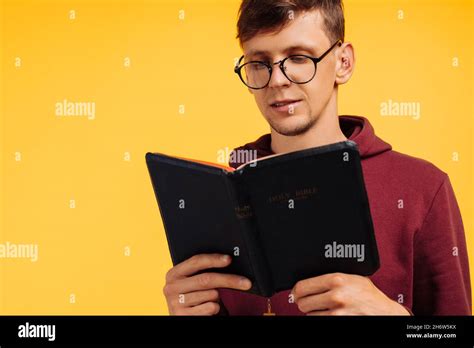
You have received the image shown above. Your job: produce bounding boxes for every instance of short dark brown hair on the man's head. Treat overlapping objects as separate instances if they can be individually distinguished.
[237,0,345,45]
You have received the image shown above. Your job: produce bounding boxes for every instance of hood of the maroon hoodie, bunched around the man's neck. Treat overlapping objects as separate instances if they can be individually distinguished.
[231,116,392,168]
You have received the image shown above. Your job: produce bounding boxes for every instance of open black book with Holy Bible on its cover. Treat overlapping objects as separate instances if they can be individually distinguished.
[146,140,379,297]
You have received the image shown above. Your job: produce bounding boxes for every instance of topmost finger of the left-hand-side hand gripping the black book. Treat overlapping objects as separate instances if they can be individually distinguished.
[167,254,231,280]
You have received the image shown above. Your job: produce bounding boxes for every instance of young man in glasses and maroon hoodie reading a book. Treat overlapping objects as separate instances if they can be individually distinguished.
[164,0,471,315]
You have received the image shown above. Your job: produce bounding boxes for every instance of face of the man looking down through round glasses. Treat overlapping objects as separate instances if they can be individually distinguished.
[243,11,336,136]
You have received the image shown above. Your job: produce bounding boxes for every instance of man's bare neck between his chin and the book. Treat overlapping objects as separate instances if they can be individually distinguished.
[271,93,347,154]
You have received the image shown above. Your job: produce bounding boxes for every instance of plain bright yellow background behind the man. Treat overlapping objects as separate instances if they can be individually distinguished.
[0,0,474,314]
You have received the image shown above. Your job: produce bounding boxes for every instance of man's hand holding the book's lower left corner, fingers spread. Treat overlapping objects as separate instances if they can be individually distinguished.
[163,254,252,315]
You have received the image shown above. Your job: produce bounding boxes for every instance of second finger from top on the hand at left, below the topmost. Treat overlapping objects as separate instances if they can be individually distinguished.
[169,273,252,294]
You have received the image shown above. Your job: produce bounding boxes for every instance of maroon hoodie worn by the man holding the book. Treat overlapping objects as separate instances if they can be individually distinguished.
[219,116,471,315]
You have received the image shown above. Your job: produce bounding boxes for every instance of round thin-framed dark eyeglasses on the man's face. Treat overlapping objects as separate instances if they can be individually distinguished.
[234,40,342,89]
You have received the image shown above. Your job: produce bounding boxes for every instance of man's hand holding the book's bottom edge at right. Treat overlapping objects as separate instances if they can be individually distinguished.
[291,273,410,315]
